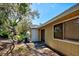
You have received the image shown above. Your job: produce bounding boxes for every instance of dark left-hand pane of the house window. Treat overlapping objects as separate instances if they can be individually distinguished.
[54,23,63,39]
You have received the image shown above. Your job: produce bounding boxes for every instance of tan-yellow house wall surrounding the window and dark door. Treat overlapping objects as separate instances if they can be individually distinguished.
[39,10,79,55]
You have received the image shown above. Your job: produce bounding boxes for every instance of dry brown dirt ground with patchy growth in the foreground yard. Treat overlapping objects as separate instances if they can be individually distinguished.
[0,40,59,56]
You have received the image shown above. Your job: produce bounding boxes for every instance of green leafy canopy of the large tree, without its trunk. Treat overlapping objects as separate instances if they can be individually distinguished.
[0,3,39,39]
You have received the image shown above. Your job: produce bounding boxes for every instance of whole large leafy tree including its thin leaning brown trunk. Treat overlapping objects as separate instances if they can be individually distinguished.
[0,3,39,55]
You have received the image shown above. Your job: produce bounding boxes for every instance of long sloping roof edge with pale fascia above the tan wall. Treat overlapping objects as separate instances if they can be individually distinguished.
[38,4,79,28]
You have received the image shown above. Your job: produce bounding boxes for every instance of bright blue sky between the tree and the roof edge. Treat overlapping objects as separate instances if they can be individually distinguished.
[31,3,75,25]
